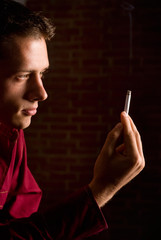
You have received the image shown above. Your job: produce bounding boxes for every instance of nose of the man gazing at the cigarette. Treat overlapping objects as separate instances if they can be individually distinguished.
[26,74,48,101]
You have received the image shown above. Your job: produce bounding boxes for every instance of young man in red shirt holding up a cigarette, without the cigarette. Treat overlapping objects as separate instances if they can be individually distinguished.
[0,0,145,240]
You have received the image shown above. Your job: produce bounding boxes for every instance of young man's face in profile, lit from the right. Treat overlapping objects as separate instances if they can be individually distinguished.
[0,36,49,129]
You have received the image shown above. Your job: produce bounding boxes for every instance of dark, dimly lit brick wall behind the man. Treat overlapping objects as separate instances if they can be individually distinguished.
[25,0,161,240]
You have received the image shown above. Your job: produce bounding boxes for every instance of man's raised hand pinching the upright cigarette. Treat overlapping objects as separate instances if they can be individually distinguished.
[89,112,145,207]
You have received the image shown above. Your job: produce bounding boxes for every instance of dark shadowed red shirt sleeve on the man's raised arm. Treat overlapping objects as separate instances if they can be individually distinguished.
[0,186,107,240]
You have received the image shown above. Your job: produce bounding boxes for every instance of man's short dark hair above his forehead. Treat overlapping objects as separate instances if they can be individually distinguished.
[0,0,55,40]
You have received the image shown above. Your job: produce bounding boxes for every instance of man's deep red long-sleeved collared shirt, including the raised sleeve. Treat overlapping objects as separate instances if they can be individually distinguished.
[0,123,107,240]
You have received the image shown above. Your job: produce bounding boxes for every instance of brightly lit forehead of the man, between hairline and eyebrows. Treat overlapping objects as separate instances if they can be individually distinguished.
[0,37,49,71]
